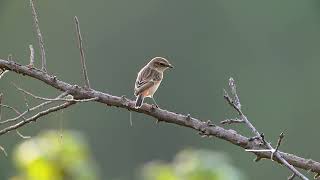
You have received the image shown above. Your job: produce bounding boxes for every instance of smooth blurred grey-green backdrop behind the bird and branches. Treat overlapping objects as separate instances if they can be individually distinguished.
[0,0,320,180]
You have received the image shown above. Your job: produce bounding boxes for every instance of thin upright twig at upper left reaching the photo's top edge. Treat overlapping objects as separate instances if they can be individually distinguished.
[30,0,47,72]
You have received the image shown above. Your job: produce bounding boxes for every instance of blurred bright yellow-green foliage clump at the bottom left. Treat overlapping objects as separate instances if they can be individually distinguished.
[12,131,98,180]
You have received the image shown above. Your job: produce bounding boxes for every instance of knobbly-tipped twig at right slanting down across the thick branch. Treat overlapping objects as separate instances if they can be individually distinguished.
[224,77,308,180]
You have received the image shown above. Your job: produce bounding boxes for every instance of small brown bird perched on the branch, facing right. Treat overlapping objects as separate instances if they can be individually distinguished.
[134,57,173,109]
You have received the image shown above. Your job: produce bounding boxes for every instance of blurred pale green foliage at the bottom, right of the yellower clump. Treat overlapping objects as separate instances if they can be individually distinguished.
[142,150,243,180]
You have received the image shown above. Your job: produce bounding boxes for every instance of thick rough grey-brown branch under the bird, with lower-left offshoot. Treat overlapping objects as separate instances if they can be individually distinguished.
[0,59,320,179]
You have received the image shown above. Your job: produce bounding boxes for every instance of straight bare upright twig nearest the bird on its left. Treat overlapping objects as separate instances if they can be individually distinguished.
[74,16,90,89]
